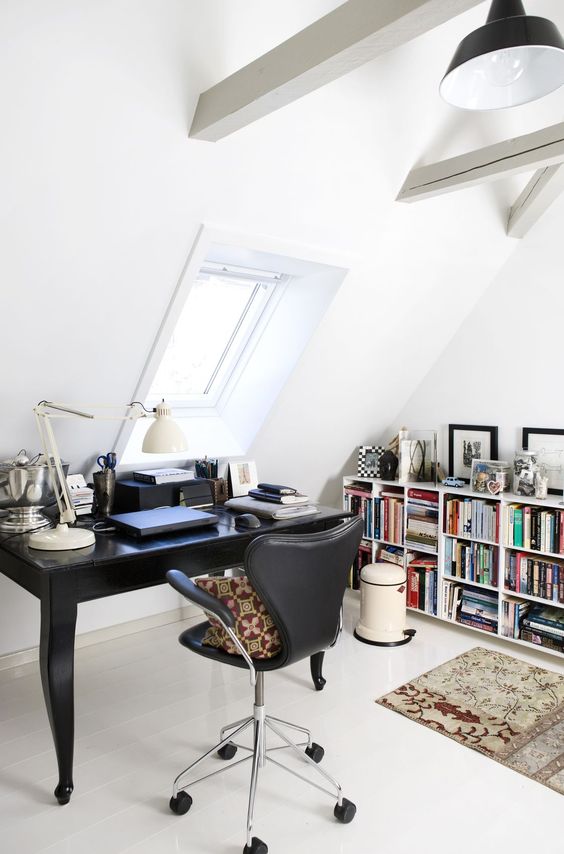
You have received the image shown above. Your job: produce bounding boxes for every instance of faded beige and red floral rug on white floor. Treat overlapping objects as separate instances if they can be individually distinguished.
[376,647,564,794]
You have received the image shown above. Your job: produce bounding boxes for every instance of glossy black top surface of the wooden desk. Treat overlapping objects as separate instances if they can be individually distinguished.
[0,507,350,571]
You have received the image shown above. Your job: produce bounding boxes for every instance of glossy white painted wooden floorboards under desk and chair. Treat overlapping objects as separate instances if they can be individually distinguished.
[0,594,564,854]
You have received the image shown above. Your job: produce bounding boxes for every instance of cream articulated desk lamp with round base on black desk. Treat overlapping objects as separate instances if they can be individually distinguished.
[29,400,188,551]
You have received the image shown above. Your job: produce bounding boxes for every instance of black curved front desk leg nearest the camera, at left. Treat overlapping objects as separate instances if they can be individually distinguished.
[39,577,77,805]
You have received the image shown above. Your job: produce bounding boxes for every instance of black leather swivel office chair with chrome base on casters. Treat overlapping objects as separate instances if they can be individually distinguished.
[166,518,363,854]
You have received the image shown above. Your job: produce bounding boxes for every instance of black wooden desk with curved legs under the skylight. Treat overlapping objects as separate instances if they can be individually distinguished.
[0,507,349,804]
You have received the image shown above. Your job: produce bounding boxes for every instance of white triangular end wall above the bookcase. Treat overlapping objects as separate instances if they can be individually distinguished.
[393,188,564,467]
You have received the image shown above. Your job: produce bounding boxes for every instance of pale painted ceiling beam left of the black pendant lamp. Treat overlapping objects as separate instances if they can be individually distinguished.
[190,0,481,142]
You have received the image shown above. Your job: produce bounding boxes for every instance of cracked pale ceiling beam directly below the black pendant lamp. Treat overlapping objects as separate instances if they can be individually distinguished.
[397,122,564,202]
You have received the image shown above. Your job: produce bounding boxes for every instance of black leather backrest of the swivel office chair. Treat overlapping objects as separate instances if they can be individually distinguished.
[245,517,363,666]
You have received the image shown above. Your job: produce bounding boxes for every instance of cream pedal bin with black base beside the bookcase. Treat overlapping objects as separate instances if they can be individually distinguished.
[354,562,415,646]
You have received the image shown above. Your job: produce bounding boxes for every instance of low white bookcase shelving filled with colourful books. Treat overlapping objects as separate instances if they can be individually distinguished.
[343,475,564,658]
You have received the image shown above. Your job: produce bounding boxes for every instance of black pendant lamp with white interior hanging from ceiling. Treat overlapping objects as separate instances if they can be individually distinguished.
[440,0,564,110]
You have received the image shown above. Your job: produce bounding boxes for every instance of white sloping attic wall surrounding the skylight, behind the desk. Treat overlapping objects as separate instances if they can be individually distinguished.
[0,0,562,653]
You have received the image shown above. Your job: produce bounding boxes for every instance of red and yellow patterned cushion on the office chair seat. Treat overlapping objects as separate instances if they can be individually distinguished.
[195,575,282,658]
